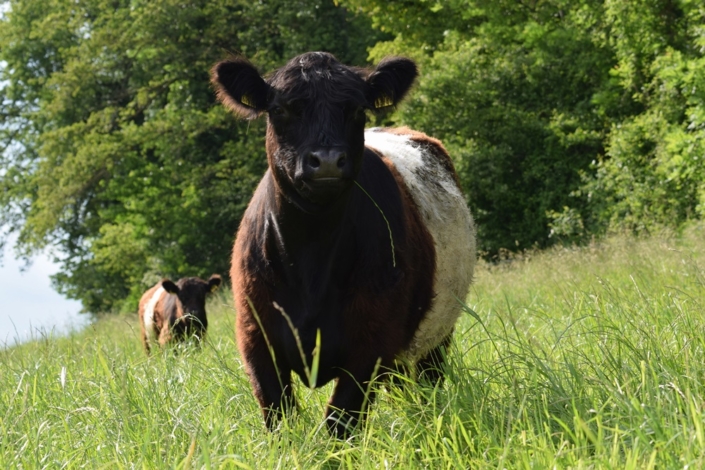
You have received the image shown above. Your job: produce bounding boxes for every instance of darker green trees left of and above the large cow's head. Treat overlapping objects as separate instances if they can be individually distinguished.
[0,0,380,312]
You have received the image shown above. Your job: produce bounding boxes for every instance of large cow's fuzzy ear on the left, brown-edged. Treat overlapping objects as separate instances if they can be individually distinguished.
[211,57,269,119]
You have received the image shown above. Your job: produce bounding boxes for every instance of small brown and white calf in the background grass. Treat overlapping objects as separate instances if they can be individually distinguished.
[139,274,221,354]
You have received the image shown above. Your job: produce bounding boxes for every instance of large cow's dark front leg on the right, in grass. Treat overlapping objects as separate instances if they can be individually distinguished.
[326,358,390,439]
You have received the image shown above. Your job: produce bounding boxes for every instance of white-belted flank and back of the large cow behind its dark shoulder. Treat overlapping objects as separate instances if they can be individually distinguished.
[365,128,475,361]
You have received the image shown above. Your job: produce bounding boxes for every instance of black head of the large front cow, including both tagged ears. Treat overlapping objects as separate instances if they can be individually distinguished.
[212,52,417,207]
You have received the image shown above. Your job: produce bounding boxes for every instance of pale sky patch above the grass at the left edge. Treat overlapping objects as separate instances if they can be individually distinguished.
[0,240,90,349]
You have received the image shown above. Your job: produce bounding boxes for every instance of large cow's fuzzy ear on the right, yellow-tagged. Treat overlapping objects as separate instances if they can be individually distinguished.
[367,57,418,110]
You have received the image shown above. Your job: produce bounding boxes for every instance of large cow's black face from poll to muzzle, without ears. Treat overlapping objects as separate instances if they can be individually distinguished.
[266,53,371,206]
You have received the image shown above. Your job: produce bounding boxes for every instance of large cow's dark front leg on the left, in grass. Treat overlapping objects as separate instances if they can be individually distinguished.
[241,337,295,431]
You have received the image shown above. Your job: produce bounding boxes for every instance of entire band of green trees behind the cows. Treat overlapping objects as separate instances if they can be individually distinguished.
[0,0,705,311]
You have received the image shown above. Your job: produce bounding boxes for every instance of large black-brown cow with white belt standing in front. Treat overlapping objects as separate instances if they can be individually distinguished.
[212,52,476,437]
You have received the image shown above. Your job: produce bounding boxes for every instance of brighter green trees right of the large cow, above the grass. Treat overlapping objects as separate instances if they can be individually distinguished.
[343,0,705,256]
